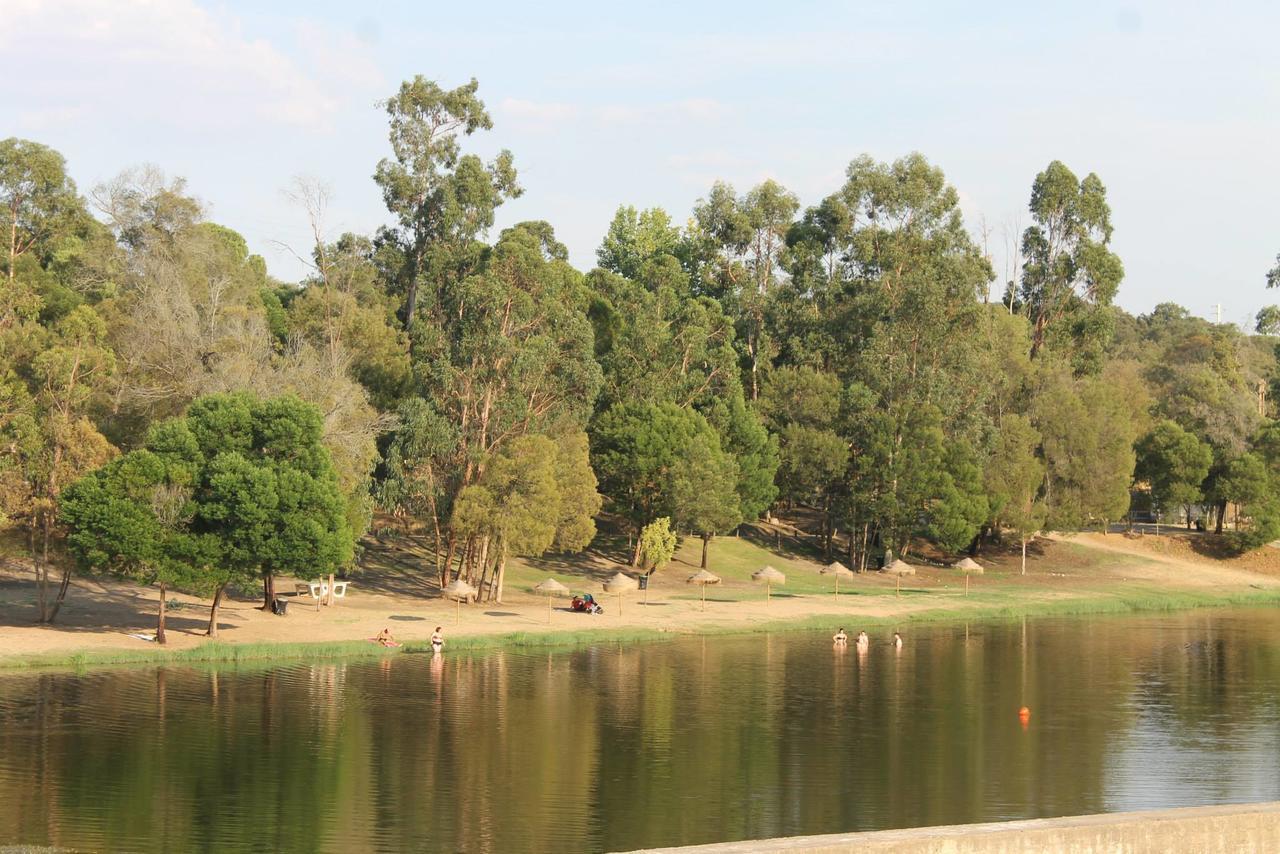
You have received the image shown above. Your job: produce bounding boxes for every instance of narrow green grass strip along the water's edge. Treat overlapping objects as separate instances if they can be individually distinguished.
[10,586,1280,677]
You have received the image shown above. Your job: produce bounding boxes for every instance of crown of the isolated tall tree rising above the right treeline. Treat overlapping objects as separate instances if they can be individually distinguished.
[1021,160,1124,356]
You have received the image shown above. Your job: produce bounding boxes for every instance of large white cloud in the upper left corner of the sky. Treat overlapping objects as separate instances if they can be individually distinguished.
[0,0,375,132]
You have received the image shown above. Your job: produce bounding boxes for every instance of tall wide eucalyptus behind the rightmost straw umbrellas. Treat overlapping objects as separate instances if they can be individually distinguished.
[831,154,992,566]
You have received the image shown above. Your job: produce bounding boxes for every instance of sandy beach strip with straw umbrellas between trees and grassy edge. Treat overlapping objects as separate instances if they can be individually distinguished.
[0,534,1280,667]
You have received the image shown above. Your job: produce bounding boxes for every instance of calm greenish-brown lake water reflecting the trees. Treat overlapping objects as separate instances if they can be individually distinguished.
[0,611,1280,851]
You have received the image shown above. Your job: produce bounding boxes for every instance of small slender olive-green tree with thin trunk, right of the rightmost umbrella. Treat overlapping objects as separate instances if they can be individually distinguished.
[986,414,1046,575]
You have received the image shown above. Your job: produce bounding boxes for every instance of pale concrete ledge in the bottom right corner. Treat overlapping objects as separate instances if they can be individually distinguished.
[624,802,1280,854]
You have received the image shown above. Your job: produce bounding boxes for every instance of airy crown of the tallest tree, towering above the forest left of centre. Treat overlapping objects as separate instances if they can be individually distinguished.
[374,76,521,330]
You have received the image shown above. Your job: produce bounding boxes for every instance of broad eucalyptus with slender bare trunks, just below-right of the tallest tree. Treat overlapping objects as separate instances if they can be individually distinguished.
[393,223,600,581]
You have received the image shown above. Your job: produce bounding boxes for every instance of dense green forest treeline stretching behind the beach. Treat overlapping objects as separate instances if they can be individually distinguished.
[0,77,1280,620]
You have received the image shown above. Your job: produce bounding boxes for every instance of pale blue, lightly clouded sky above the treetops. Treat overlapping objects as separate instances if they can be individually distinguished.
[0,0,1280,324]
